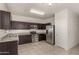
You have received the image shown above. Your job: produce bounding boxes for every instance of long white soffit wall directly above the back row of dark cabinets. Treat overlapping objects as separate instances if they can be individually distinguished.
[12,14,53,23]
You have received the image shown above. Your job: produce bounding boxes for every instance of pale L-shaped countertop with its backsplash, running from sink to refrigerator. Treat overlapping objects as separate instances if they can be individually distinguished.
[0,30,46,42]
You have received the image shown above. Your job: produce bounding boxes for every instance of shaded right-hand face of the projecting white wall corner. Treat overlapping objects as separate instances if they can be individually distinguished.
[68,10,79,49]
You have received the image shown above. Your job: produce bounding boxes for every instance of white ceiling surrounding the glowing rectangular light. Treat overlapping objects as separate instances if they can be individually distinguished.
[6,3,79,19]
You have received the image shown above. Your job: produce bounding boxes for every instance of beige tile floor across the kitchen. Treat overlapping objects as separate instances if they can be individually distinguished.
[18,41,79,55]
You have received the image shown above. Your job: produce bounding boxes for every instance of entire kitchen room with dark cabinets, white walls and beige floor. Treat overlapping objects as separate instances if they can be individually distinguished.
[0,3,79,55]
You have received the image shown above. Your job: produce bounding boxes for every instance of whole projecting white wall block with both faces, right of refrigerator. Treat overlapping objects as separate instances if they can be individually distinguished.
[55,9,79,50]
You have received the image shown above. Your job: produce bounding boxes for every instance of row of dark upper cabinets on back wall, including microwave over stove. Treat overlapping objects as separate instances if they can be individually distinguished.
[11,21,46,29]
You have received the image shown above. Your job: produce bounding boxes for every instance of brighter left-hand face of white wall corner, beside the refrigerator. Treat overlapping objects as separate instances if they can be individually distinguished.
[55,9,68,49]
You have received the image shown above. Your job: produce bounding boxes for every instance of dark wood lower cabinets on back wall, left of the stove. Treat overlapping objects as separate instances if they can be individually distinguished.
[19,35,32,45]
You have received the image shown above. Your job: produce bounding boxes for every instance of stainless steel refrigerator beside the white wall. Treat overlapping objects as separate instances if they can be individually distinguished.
[46,25,55,45]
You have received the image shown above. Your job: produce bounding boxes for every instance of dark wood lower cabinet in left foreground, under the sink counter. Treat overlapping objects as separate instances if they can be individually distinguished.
[0,41,18,55]
